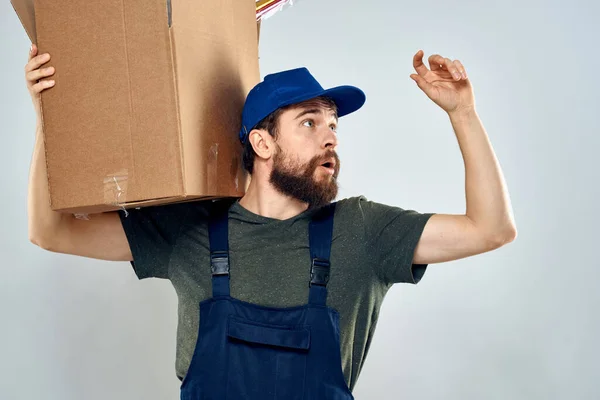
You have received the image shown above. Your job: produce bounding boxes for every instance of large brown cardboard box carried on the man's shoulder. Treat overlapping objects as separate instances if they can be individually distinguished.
[11,0,260,213]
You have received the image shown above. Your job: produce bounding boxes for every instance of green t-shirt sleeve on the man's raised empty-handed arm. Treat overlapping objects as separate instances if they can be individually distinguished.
[360,198,434,285]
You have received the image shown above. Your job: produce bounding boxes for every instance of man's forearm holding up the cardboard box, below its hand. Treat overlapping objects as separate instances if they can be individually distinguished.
[27,120,69,247]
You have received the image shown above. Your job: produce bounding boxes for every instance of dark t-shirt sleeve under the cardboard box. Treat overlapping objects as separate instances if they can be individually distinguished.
[119,203,192,279]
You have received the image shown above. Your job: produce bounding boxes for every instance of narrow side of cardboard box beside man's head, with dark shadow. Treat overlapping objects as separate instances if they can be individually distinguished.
[172,0,260,196]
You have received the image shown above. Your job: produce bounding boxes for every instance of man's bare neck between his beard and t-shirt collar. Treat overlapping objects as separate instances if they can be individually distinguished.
[240,177,308,220]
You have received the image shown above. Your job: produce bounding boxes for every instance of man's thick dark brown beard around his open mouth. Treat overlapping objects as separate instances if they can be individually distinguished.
[269,146,340,208]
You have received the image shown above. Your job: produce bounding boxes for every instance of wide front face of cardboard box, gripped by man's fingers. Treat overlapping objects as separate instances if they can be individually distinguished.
[35,0,183,209]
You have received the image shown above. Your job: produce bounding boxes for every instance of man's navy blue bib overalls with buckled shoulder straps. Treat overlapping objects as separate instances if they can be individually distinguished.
[181,203,353,400]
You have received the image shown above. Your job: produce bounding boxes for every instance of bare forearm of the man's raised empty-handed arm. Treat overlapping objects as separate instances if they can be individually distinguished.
[449,110,516,241]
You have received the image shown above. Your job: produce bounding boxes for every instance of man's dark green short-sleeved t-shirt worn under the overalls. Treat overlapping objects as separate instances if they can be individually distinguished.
[119,197,433,390]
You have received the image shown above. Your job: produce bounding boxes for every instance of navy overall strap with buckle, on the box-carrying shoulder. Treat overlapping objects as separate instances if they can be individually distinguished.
[208,201,230,297]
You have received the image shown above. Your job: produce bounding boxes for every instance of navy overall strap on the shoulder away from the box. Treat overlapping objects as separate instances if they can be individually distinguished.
[308,203,335,306]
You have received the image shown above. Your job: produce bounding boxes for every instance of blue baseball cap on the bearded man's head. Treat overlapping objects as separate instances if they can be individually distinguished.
[240,67,366,143]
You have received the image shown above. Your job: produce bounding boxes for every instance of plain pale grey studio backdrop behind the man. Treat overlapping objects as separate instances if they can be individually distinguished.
[0,0,600,400]
